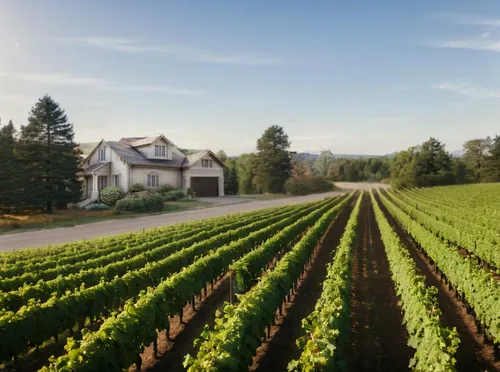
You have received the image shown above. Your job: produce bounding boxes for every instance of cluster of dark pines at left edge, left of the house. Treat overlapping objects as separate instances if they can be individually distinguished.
[0,95,82,213]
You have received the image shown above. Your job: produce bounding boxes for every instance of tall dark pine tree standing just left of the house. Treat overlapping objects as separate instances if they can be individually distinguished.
[19,95,82,213]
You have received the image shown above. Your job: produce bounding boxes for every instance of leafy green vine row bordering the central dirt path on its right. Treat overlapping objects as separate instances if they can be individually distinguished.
[370,193,460,372]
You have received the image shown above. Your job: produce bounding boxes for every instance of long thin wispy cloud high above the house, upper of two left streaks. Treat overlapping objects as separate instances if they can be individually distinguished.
[52,37,280,66]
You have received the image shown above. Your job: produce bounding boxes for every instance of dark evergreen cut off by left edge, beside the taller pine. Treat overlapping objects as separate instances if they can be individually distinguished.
[0,120,22,213]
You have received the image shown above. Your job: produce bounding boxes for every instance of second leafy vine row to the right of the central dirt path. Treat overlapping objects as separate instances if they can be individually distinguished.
[379,193,500,347]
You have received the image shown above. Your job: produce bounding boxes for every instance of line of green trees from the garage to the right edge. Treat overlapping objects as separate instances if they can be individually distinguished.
[218,126,500,195]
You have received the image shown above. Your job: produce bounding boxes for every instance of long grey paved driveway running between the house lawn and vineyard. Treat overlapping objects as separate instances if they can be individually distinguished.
[0,192,340,252]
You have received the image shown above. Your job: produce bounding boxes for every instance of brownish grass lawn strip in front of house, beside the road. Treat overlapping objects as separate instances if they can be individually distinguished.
[0,198,212,235]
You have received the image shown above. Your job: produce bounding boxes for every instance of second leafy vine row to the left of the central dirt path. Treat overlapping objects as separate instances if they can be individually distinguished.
[184,193,352,372]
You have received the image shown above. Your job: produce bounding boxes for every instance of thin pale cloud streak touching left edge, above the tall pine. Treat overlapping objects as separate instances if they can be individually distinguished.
[0,73,204,95]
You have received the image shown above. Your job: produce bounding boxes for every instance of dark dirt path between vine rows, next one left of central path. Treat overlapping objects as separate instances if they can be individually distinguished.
[250,198,352,371]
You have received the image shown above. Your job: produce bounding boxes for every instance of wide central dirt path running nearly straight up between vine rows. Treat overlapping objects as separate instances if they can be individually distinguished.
[347,199,412,371]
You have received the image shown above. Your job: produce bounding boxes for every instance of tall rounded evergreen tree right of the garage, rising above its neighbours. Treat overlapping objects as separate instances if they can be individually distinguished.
[255,125,292,193]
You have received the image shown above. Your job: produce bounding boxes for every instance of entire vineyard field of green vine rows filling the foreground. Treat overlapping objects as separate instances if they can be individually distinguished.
[0,184,500,371]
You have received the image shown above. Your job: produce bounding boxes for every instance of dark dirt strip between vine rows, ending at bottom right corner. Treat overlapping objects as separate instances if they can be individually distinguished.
[377,197,500,372]
